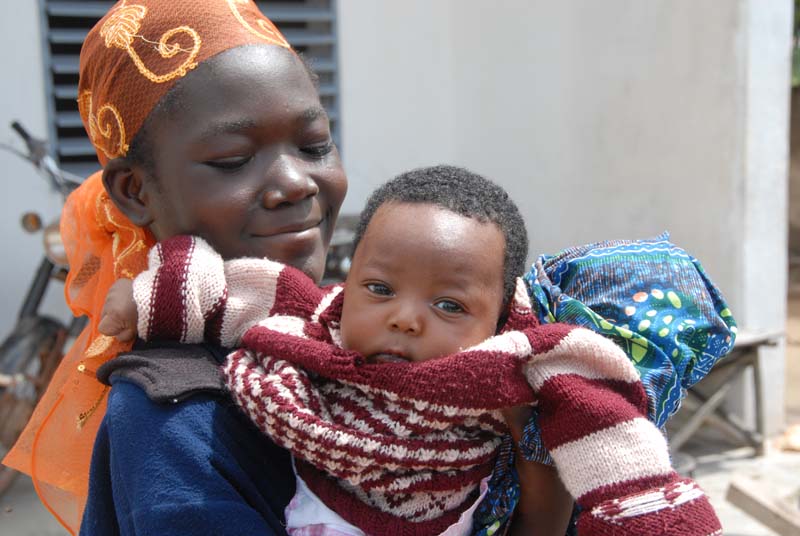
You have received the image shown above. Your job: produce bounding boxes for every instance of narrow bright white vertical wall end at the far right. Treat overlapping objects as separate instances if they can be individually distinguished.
[733,0,792,430]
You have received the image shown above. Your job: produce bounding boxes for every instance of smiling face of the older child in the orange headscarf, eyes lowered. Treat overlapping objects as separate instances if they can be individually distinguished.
[141,46,347,281]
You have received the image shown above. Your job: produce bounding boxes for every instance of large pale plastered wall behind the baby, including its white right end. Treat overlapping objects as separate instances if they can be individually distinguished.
[339,0,792,430]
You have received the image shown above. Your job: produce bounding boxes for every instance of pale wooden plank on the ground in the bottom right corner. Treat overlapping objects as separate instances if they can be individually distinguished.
[725,477,800,536]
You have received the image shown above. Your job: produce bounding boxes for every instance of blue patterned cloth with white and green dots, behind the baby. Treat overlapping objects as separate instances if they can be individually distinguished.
[473,233,736,536]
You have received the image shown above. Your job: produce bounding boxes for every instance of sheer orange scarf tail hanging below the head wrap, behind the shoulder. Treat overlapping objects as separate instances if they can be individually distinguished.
[3,172,154,530]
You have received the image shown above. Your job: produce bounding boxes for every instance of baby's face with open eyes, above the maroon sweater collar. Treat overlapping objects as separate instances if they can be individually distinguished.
[341,203,505,363]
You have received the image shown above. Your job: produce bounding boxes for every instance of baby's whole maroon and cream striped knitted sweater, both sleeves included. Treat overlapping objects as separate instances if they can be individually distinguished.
[134,237,721,535]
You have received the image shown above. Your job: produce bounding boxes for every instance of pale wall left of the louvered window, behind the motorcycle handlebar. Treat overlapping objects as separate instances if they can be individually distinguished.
[0,1,67,336]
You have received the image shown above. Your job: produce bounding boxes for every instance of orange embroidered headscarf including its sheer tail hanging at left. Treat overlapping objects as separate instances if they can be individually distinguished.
[3,0,289,534]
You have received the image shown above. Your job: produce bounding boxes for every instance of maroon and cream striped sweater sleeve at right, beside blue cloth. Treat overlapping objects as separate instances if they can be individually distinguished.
[525,324,722,536]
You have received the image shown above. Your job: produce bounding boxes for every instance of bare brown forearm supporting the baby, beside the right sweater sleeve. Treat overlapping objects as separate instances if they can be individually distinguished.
[503,406,573,536]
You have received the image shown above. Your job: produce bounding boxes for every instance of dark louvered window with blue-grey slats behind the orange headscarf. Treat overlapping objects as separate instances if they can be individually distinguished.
[40,0,339,176]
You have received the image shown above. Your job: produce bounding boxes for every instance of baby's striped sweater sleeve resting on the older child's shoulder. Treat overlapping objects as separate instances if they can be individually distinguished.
[133,236,304,348]
